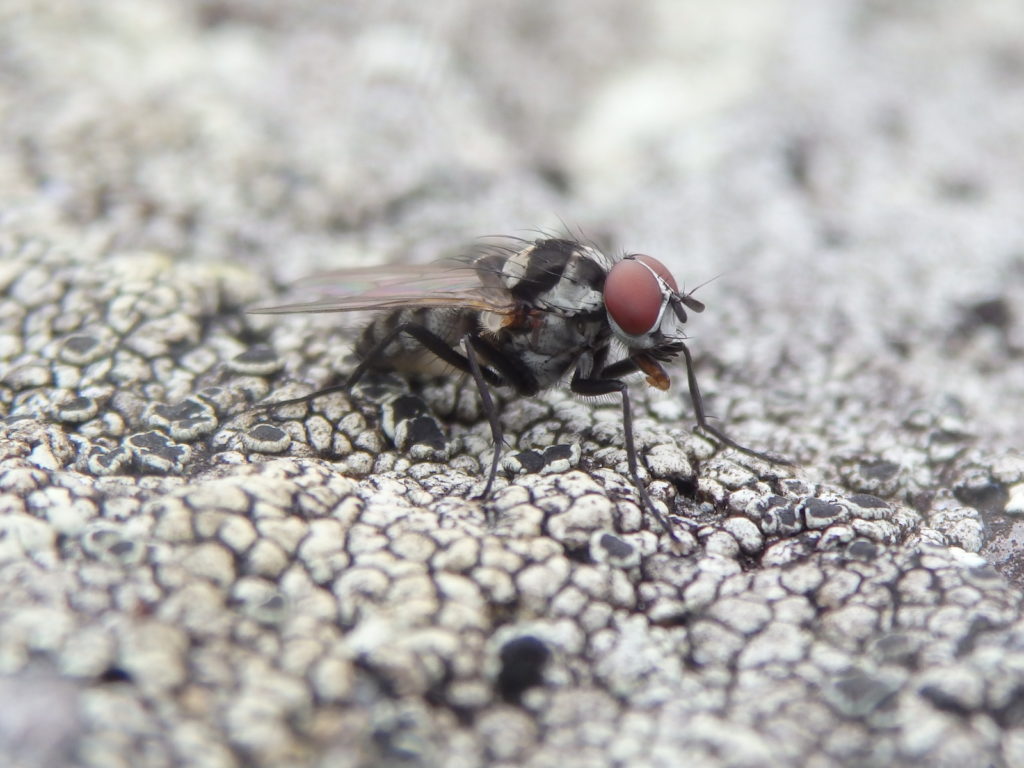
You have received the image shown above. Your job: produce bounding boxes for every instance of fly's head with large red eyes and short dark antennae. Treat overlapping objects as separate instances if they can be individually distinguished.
[604,254,705,360]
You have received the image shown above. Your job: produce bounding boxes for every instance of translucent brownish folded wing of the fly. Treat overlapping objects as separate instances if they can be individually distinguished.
[249,262,514,314]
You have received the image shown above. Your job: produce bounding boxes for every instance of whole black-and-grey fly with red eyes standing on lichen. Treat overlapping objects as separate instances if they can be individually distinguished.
[250,238,787,539]
